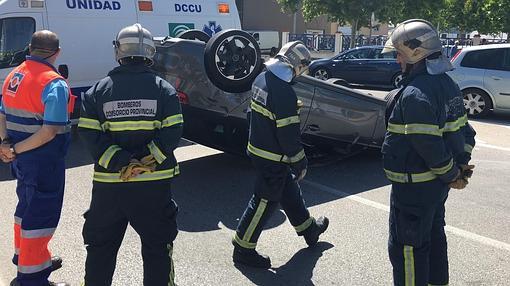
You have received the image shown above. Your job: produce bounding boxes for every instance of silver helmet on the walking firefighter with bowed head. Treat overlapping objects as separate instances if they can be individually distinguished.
[266,41,312,82]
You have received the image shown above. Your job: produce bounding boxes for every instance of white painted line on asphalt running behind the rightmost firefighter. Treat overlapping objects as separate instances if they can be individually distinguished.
[302,180,510,251]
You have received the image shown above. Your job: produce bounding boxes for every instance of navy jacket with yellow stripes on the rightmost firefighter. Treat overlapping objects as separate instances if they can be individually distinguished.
[382,64,476,183]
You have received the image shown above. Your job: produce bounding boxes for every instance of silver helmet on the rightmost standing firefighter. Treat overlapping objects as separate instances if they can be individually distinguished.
[382,19,452,74]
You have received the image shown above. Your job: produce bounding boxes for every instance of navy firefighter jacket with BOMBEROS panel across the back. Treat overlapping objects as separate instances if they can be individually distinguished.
[78,65,183,183]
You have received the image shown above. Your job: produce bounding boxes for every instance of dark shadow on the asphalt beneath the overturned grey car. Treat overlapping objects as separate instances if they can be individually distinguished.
[172,147,388,232]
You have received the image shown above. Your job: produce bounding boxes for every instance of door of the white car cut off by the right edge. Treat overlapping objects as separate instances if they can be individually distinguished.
[483,48,510,109]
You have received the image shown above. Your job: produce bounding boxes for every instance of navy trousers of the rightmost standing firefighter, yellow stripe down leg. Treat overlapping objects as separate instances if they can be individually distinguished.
[388,180,449,286]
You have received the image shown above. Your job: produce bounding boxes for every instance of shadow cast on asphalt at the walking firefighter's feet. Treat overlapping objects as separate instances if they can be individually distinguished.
[234,241,334,286]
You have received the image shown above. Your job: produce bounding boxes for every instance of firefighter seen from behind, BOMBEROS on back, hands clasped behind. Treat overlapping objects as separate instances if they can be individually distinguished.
[78,24,183,286]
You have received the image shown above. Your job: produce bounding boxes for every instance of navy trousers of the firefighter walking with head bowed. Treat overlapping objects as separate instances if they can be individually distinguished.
[234,165,314,249]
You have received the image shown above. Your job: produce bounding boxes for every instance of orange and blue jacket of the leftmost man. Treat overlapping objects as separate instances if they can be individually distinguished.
[0,56,74,160]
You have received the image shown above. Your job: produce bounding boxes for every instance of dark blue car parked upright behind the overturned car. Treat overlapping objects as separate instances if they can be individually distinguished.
[310,46,402,88]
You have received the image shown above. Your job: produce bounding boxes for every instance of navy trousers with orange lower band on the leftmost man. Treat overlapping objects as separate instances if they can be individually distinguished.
[11,158,65,286]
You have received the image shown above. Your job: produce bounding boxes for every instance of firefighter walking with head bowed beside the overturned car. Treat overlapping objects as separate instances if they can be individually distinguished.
[232,42,329,269]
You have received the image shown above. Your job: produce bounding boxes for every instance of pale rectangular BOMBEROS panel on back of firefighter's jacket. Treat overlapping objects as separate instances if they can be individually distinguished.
[103,99,158,119]
